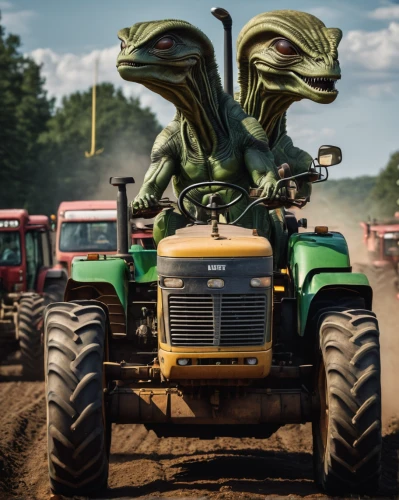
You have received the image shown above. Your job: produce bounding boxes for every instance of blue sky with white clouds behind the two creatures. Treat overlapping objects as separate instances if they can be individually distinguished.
[0,0,399,179]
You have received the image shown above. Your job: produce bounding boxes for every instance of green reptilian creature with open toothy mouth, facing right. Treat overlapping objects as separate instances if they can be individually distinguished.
[237,10,342,188]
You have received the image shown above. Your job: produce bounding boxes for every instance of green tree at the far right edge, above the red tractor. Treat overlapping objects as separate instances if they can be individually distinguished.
[371,151,399,217]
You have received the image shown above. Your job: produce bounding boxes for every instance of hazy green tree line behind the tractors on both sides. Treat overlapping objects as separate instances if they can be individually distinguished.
[0,18,399,217]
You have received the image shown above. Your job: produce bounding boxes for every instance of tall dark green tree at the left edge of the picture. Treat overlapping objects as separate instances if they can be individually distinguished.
[0,17,52,208]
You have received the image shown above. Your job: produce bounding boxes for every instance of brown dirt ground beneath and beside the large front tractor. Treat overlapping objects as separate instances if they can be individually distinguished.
[0,193,399,500]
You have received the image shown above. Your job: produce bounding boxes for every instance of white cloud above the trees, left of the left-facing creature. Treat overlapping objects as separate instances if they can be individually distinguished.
[28,45,174,125]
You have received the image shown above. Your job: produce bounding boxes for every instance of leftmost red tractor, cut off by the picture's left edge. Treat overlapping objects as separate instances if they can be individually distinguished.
[0,209,67,379]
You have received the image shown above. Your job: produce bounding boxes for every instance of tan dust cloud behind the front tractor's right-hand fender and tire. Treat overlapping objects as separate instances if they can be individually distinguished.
[297,185,399,427]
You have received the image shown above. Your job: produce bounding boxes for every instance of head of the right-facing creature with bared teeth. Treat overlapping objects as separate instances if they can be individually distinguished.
[237,10,342,109]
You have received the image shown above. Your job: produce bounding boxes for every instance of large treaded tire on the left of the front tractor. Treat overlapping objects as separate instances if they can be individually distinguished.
[45,301,110,497]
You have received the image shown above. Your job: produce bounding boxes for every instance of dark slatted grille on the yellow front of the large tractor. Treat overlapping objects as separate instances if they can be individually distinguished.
[169,294,266,346]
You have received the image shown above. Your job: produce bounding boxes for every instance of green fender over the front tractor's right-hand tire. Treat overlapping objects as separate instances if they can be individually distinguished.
[288,232,372,336]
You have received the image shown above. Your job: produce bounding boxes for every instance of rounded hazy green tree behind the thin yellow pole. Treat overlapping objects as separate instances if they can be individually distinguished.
[40,83,161,210]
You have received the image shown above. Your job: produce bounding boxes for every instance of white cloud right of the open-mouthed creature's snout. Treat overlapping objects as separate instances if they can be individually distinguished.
[339,21,399,73]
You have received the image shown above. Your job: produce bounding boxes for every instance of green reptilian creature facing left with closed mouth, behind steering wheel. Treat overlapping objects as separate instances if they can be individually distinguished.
[117,20,277,241]
